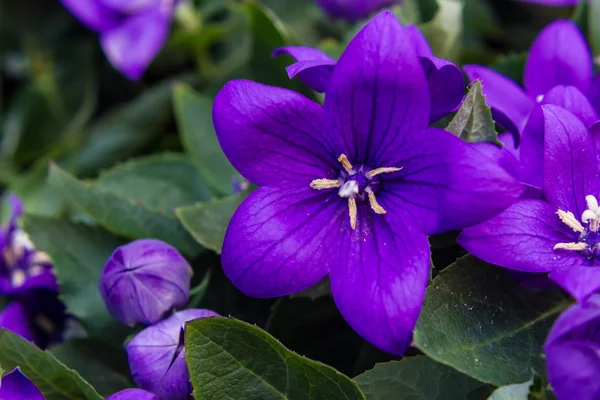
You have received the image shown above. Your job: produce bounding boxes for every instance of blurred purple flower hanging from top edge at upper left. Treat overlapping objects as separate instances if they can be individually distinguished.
[61,0,179,80]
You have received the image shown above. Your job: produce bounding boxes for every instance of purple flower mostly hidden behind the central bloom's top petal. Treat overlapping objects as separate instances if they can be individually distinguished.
[273,25,465,123]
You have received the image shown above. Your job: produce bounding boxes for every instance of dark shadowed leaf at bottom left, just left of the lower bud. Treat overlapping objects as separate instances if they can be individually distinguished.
[52,339,133,397]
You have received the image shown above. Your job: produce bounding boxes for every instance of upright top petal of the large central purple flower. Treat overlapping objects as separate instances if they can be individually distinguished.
[323,11,430,167]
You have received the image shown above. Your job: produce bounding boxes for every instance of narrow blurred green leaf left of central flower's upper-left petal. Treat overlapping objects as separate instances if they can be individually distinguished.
[173,84,237,195]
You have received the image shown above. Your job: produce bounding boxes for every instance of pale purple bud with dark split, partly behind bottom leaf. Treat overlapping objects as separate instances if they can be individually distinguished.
[125,309,219,400]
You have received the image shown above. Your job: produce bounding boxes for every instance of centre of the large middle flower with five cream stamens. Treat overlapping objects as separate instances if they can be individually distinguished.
[310,154,402,229]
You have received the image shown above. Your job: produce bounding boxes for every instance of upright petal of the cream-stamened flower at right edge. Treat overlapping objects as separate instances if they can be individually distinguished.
[542,105,599,218]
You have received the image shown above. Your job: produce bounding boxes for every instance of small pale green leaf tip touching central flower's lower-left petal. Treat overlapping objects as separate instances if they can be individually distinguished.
[175,192,248,253]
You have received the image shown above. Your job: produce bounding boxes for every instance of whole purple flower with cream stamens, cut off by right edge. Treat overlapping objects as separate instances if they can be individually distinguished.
[458,105,600,301]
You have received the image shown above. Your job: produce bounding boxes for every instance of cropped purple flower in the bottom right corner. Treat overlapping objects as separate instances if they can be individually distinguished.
[544,295,600,400]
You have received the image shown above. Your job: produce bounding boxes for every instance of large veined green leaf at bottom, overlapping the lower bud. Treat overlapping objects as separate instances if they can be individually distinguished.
[185,318,364,400]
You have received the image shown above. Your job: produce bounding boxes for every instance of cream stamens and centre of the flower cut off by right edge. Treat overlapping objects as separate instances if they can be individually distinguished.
[554,195,600,258]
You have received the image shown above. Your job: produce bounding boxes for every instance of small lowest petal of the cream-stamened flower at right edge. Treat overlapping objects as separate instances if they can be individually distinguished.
[549,265,600,302]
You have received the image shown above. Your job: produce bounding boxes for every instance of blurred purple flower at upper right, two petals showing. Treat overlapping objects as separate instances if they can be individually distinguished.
[464,20,600,139]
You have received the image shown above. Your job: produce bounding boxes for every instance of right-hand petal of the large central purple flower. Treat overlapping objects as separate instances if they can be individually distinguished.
[381,129,523,235]
